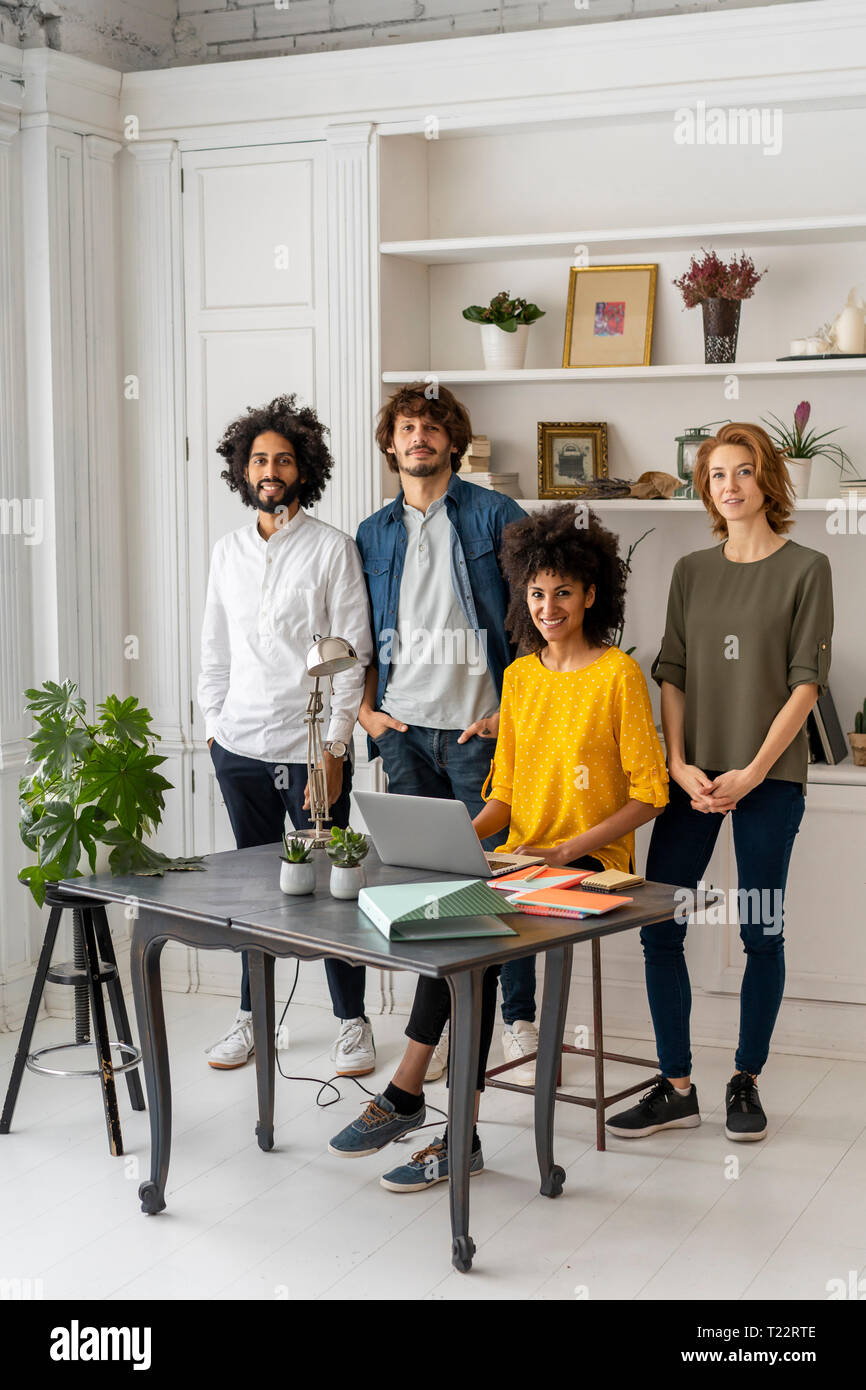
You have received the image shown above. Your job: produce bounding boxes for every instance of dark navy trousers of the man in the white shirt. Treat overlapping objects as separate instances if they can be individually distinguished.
[210,738,367,1019]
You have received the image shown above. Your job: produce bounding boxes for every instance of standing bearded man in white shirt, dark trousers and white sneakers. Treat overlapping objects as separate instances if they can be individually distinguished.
[199,395,375,1076]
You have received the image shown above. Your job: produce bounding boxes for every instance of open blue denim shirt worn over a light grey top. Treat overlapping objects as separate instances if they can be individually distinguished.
[356,473,525,709]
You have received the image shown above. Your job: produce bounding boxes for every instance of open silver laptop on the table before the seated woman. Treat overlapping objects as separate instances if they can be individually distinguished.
[354,791,544,878]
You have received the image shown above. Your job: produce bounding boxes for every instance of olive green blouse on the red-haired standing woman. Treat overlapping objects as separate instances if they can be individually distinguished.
[652,541,833,791]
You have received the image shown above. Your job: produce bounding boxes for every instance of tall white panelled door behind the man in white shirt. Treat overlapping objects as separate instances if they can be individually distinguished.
[182,142,329,853]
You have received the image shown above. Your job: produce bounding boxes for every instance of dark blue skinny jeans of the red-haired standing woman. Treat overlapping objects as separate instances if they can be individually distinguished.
[641,771,805,1077]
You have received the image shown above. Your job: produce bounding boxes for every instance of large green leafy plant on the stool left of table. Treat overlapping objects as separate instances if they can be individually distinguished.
[18,680,202,906]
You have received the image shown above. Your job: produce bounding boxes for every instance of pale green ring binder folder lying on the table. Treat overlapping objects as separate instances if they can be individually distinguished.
[357,878,517,941]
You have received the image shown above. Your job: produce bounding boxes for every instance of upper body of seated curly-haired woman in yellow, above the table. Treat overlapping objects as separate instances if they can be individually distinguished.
[474,503,667,872]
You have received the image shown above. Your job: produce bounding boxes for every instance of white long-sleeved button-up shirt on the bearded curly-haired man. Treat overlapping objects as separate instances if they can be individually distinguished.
[197,507,373,763]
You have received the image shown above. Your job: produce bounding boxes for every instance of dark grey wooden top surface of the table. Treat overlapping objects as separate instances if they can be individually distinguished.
[60,844,677,977]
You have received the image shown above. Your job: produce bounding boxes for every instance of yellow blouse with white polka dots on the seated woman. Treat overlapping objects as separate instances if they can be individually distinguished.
[485,646,667,872]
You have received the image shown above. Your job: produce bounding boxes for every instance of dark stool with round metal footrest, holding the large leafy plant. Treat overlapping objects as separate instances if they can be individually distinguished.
[0,885,145,1155]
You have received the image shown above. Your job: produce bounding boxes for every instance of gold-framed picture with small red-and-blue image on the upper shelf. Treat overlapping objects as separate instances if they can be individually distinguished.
[563,265,659,367]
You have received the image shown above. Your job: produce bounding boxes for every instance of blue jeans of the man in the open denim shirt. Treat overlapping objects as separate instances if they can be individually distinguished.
[377,724,535,1023]
